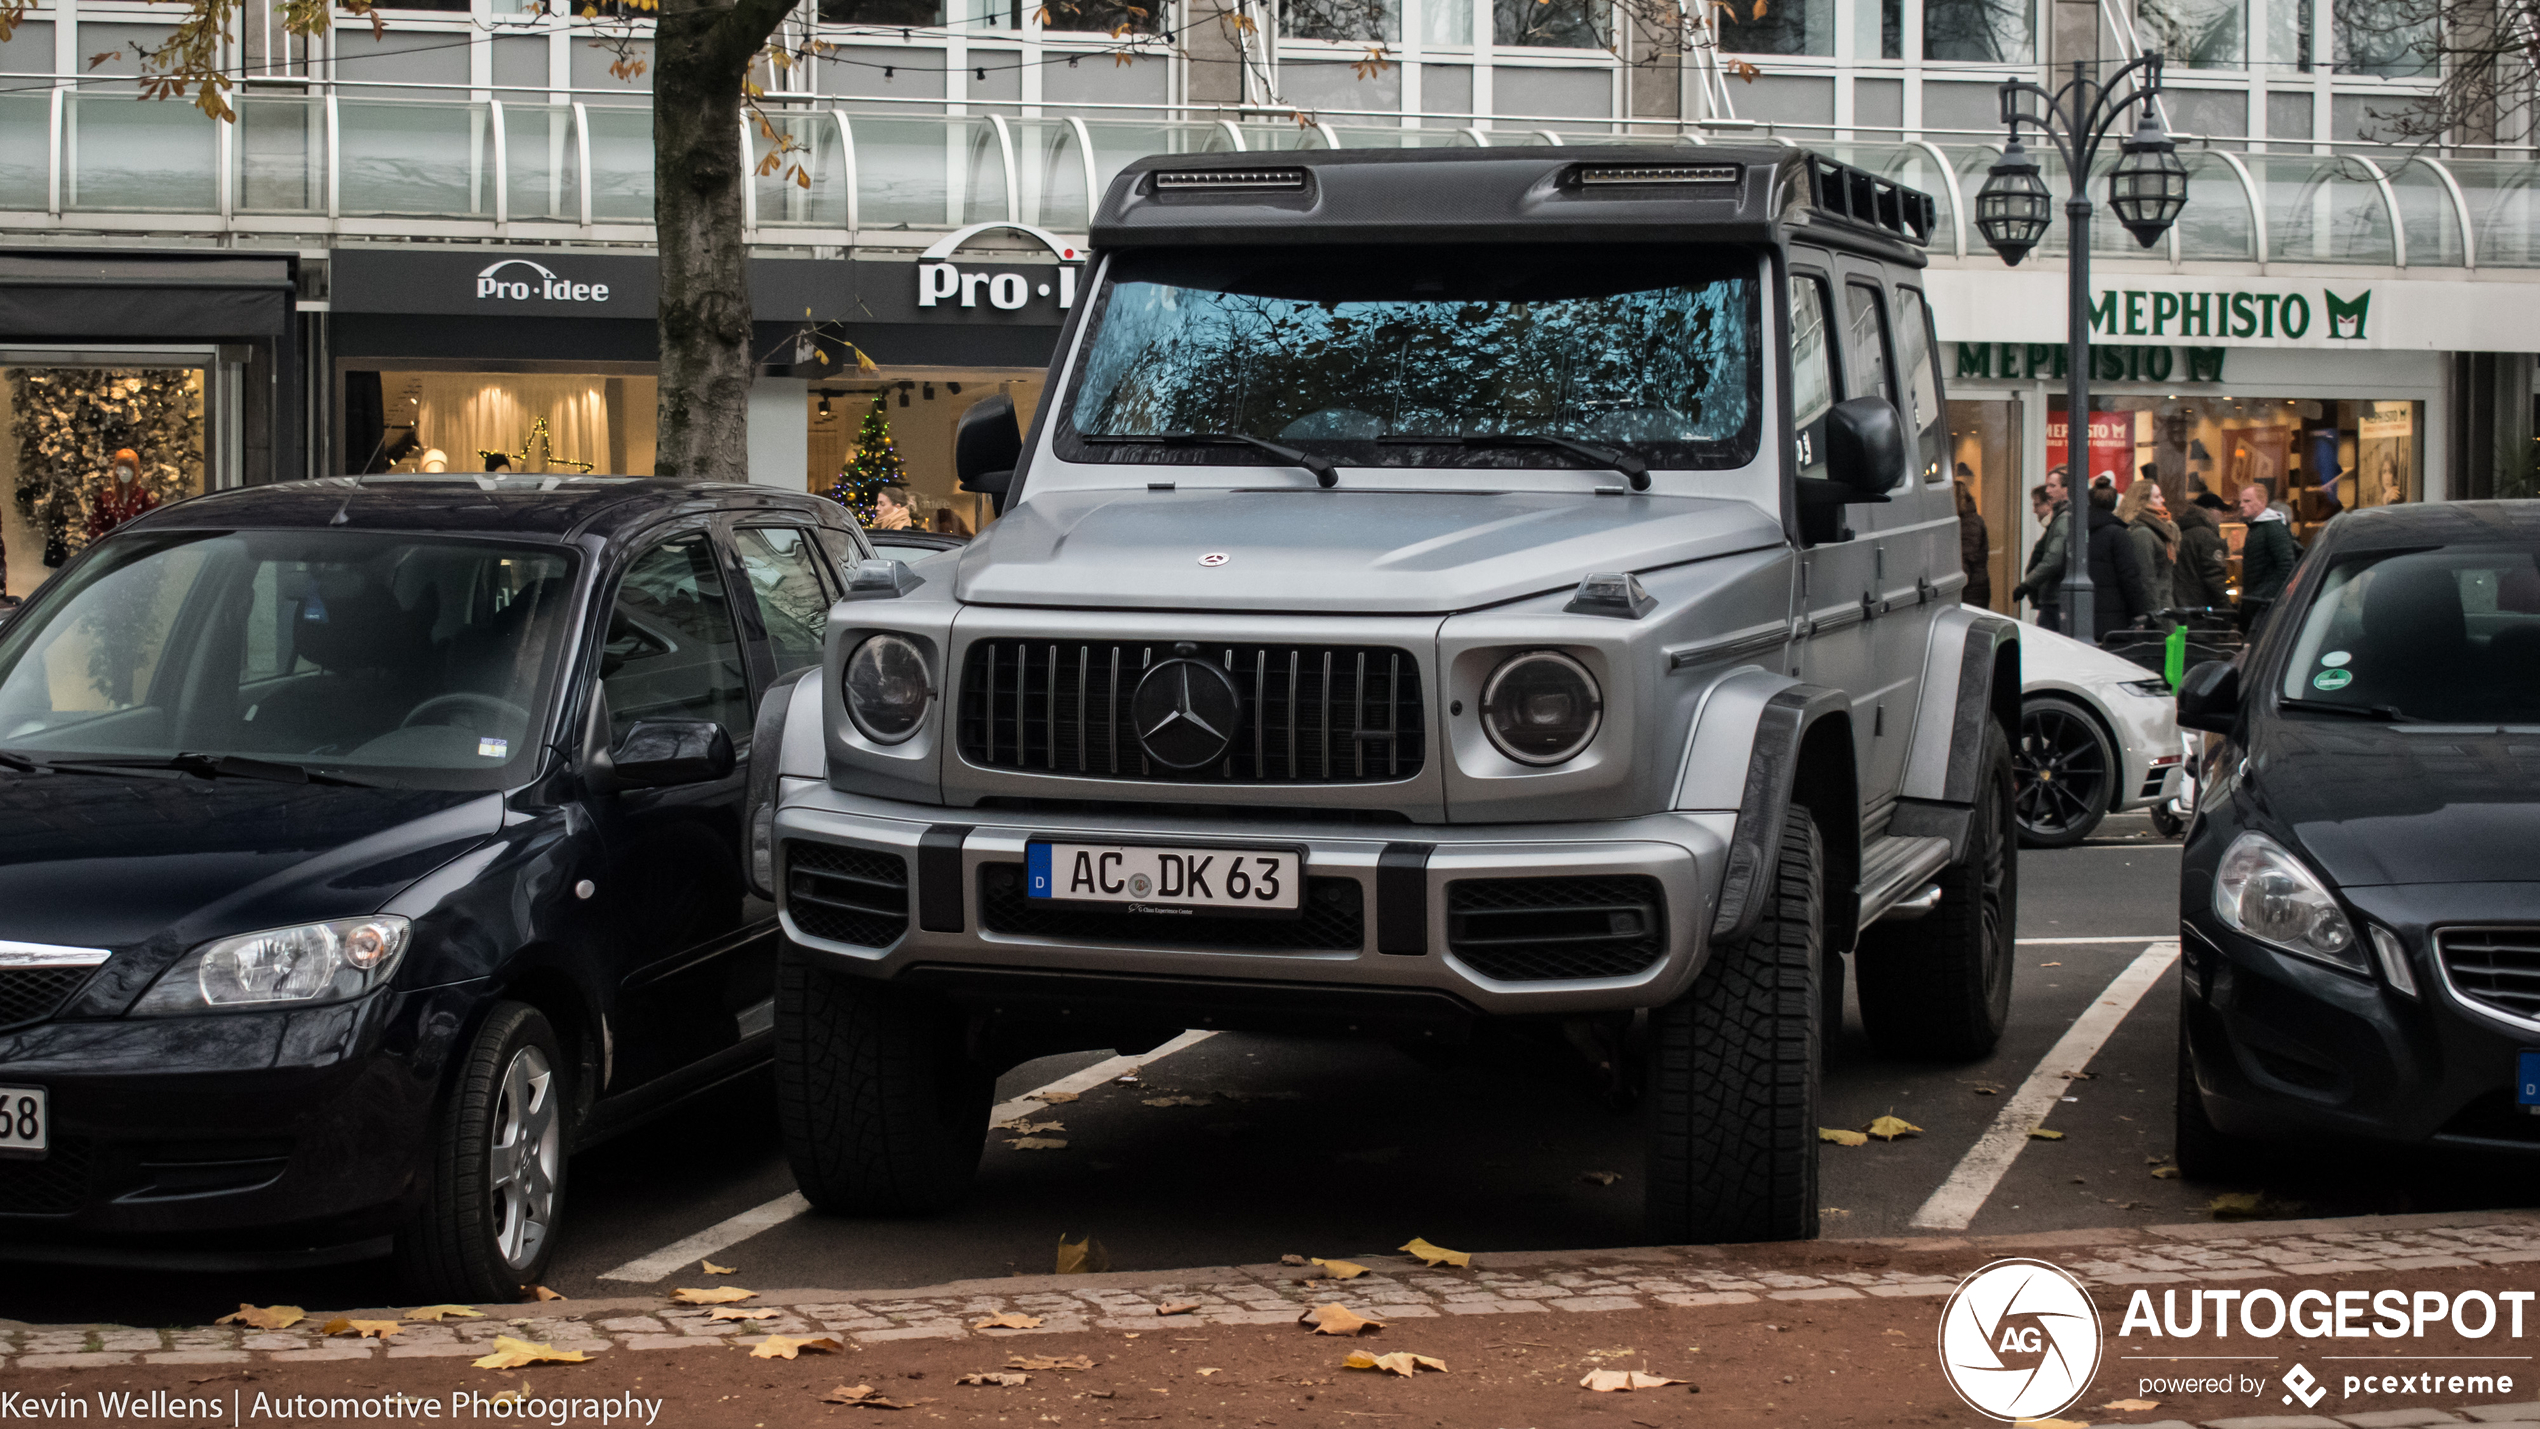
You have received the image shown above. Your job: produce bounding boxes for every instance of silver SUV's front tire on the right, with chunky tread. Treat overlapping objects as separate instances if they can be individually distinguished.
[1646,805,1826,1244]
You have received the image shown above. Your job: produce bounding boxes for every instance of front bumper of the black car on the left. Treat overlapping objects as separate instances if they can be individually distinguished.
[0,985,478,1264]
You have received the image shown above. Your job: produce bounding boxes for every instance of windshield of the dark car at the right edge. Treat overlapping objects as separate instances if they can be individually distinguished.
[2283,546,2540,723]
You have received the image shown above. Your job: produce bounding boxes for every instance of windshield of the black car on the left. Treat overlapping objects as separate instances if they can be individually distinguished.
[0,530,574,789]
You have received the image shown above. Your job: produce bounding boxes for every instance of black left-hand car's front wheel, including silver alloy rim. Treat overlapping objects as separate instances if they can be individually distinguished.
[396,1003,572,1302]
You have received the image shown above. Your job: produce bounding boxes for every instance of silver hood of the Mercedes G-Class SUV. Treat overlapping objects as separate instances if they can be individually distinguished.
[955,489,1783,614]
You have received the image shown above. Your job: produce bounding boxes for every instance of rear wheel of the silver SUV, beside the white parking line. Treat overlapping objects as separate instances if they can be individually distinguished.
[1852,721,2019,1061]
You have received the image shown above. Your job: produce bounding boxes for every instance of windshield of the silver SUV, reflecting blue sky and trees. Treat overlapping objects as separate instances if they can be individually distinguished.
[1059,244,1763,470]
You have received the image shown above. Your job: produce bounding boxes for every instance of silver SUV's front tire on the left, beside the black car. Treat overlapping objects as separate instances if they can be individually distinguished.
[777,944,996,1216]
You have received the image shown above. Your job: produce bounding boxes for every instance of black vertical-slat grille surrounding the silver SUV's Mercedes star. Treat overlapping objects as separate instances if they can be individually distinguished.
[960,640,1427,784]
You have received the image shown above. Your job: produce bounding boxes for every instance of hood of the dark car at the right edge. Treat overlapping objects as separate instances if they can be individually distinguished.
[2245,716,2540,886]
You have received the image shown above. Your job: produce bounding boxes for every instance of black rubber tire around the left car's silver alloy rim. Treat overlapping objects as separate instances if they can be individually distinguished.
[396,1003,577,1305]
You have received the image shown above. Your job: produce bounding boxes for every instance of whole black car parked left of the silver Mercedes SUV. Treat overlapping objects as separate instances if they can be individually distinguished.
[0,477,871,1300]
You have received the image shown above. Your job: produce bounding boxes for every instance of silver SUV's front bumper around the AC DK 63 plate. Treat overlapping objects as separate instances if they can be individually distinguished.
[775,779,1735,1015]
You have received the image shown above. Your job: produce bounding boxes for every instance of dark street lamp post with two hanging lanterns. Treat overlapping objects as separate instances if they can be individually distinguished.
[1976,51,2187,640]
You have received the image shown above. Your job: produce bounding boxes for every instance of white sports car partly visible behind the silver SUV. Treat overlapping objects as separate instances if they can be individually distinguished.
[2012,624,2187,848]
